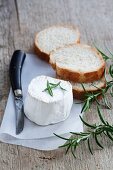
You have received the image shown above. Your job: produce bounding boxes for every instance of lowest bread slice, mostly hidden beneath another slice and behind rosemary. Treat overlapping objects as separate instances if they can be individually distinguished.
[56,75,106,100]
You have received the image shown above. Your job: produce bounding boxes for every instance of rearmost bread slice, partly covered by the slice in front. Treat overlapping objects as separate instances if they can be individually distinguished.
[34,26,80,61]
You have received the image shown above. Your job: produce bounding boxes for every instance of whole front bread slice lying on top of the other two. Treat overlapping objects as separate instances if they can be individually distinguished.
[50,44,105,83]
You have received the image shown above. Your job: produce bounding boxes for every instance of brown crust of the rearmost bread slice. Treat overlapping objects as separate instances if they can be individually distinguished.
[34,24,80,62]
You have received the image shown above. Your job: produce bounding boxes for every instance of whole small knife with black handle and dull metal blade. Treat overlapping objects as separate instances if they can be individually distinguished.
[9,50,26,135]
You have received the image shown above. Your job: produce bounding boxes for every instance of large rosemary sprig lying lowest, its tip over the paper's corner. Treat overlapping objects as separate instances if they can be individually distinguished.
[54,106,113,158]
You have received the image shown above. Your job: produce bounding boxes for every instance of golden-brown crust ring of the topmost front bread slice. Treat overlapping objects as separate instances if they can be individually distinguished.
[50,44,105,83]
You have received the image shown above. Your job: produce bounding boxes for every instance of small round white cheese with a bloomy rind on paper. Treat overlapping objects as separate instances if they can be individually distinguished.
[24,76,73,125]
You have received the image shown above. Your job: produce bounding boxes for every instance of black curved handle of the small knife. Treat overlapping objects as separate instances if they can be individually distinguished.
[9,50,26,97]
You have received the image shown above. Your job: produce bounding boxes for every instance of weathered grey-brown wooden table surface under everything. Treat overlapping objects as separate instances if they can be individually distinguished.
[0,0,113,170]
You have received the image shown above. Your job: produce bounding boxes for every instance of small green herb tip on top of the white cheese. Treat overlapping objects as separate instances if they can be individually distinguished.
[42,80,66,96]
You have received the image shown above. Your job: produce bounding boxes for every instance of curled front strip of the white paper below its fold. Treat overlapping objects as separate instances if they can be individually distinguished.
[0,131,71,151]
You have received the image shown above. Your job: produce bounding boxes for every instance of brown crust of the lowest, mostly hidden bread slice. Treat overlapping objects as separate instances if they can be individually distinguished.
[56,75,106,100]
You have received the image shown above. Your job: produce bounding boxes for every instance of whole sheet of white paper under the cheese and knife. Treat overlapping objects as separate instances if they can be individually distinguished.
[0,54,83,150]
